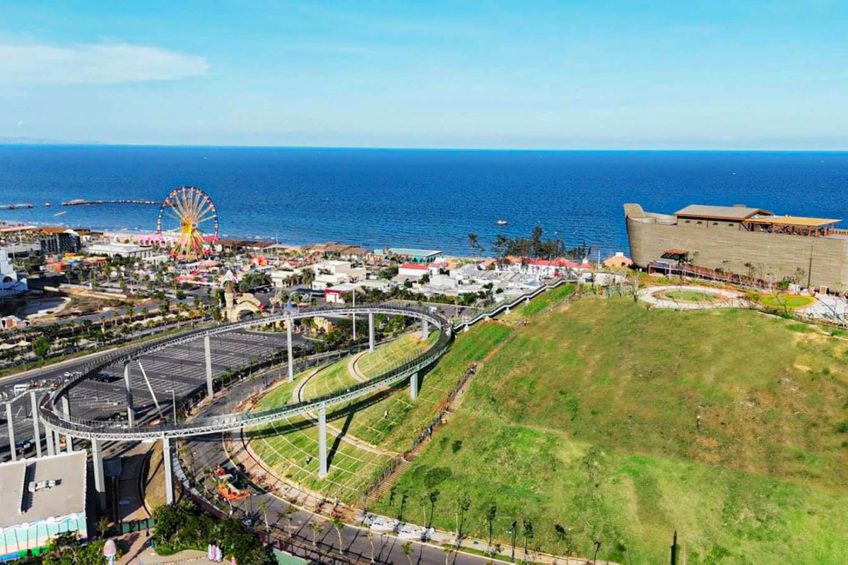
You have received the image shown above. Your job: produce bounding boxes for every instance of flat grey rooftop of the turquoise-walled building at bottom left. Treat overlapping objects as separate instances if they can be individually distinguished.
[0,451,86,528]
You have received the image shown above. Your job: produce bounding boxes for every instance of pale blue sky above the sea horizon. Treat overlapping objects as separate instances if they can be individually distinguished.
[0,0,848,149]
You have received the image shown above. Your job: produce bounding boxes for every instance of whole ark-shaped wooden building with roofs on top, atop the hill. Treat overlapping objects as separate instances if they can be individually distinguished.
[624,204,848,292]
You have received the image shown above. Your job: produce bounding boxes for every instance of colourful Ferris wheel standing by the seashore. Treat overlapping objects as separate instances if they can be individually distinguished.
[156,186,218,256]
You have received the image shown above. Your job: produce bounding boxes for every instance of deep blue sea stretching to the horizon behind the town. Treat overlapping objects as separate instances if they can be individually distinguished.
[0,146,848,253]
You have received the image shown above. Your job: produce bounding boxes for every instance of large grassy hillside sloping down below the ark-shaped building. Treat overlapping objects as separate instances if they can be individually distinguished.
[375,299,848,563]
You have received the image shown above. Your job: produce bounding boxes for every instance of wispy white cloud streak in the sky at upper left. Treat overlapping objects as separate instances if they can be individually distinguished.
[0,43,209,84]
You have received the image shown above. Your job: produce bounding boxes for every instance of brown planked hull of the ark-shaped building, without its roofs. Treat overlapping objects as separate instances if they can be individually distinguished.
[626,208,848,292]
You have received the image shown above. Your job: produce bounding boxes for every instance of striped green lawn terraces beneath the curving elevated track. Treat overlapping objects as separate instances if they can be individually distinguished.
[247,324,510,503]
